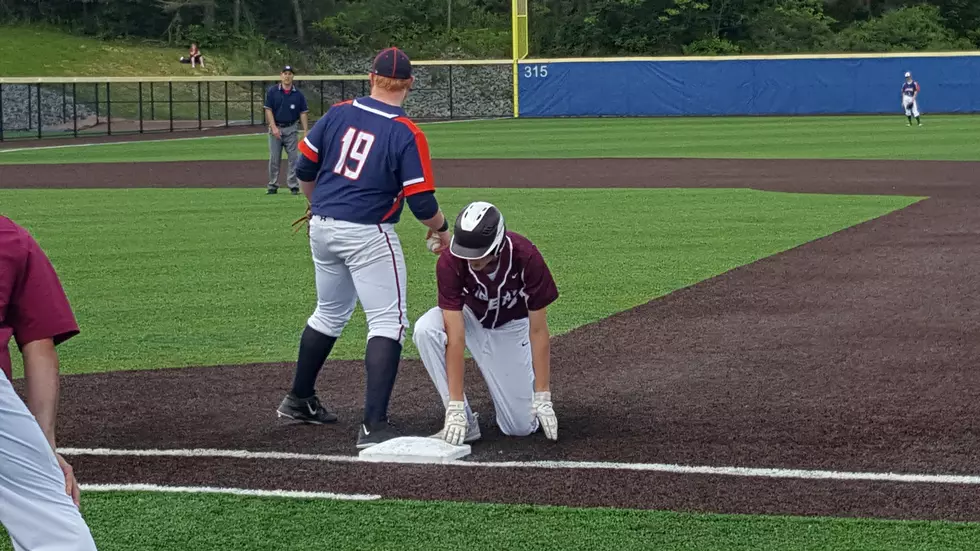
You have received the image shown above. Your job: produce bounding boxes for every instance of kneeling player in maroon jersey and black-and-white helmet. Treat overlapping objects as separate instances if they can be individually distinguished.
[412,201,558,446]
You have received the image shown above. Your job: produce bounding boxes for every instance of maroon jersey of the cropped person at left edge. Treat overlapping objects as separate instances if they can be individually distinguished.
[0,216,78,379]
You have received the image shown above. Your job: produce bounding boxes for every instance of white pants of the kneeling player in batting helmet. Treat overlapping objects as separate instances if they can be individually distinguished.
[412,307,538,436]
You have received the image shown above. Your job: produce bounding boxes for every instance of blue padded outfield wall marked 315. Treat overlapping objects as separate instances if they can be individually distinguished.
[518,56,980,117]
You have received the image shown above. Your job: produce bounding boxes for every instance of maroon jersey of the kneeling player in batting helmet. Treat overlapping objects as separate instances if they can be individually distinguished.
[436,232,558,329]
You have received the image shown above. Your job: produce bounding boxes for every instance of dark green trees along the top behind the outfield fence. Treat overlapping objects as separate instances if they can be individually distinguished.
[0,0,980,63]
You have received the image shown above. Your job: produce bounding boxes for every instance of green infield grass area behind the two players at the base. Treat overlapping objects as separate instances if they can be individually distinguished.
[0,189,914,373]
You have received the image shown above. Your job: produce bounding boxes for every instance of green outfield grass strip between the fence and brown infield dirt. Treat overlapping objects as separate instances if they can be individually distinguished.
[0,115,980,164]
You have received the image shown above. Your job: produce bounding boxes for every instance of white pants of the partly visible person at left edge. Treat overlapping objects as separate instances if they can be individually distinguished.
[0,375,95,551]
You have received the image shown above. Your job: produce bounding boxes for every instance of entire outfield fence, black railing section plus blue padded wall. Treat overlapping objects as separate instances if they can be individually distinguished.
[0,49,980,140]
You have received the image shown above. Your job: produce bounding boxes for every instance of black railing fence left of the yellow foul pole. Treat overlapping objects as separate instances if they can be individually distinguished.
[0,62,513,141]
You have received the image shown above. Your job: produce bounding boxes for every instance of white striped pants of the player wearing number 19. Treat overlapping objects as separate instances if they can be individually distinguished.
[307,216,409,343]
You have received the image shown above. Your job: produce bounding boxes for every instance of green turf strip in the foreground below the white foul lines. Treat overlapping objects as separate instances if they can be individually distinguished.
[0,492,980,551]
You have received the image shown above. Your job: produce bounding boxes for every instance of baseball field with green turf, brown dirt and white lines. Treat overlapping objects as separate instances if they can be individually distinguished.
[0,116,980,551]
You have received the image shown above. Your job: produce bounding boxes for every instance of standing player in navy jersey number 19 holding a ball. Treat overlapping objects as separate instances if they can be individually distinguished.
[278,48,450,448]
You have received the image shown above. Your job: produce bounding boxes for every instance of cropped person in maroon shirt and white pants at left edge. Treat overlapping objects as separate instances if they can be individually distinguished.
[0,216,97,551]
